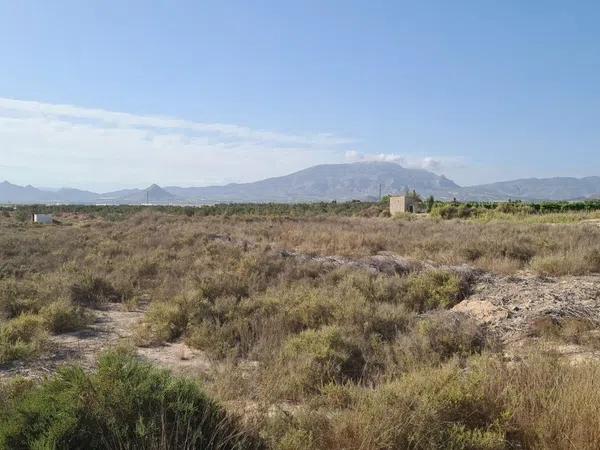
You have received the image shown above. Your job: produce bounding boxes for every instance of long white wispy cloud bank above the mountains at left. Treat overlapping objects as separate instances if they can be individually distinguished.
[0,98,352,188]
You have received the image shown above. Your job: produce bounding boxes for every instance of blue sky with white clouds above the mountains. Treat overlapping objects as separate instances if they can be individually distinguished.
[0,0,600,191]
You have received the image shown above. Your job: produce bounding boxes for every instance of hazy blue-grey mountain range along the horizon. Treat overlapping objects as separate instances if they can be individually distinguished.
[0,162,600,204]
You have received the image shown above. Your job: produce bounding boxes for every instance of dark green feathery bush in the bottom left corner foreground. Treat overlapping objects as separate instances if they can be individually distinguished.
[0,352,262,449]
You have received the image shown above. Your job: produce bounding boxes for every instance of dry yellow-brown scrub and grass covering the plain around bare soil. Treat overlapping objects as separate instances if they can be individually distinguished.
[0,213,600,450]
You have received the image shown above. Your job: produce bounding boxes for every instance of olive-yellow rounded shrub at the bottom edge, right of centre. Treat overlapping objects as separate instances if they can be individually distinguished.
[342,362,510,449]
